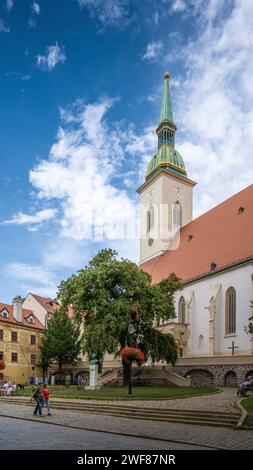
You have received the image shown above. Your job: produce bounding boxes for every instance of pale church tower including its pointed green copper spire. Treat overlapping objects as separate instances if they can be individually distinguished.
[137,72,196,264]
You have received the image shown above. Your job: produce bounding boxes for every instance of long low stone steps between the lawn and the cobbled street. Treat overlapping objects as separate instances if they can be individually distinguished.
[0,397,241,428]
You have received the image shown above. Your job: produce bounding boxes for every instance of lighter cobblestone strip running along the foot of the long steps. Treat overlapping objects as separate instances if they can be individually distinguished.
[0,400,253,449]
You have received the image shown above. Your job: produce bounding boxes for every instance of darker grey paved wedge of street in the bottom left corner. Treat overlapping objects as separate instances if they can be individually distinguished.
[0,418,208,450]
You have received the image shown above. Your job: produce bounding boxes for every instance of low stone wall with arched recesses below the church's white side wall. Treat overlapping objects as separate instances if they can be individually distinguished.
[173,364,253,387]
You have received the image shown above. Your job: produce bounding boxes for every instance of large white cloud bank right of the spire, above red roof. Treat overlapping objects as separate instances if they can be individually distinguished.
[170,0,253,214]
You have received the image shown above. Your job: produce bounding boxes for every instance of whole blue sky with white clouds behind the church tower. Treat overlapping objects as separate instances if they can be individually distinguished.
[0,0,253,302]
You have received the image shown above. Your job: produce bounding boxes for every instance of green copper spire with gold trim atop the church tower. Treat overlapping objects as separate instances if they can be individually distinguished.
[146,72,187,180]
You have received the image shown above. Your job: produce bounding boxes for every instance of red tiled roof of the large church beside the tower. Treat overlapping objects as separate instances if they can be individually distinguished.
[141,185,253,283]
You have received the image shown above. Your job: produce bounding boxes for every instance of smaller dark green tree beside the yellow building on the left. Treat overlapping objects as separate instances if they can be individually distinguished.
[40,309,82,371]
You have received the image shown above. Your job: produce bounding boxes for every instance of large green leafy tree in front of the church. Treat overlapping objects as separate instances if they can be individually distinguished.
[59,249,182,380]
